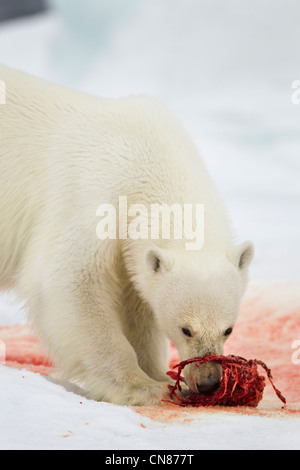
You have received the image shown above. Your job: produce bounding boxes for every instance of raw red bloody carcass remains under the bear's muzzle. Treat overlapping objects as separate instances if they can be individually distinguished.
[164,355,286,408]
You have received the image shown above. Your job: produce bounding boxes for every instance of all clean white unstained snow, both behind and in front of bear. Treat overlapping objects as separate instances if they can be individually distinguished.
[0,0,300,450]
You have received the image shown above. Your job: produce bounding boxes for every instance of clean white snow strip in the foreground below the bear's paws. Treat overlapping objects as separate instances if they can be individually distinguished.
[0,366,300,450]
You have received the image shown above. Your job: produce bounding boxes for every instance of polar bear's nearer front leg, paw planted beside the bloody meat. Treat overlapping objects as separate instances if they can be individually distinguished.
[29,275,171,405]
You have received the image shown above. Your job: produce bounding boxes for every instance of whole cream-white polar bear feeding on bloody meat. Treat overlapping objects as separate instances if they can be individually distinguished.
[0,66,254,405]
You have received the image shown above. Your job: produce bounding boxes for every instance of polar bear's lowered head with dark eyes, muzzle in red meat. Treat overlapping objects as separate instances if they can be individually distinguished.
[137,242,254,392]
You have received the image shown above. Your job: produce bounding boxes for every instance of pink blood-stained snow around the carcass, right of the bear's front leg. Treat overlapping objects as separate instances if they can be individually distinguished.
[135,283,300,423]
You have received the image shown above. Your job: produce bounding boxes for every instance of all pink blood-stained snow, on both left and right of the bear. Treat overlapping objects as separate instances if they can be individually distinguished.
[0,283,300,424]
